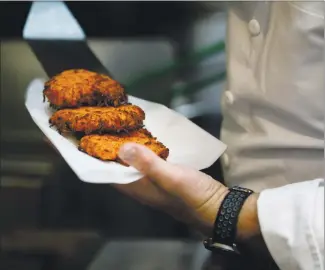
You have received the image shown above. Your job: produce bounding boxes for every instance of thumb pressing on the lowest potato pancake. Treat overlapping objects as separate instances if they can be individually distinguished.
[118,143,179,190]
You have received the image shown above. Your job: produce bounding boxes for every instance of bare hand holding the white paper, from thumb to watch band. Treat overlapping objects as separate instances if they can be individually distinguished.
[114,143,228,234]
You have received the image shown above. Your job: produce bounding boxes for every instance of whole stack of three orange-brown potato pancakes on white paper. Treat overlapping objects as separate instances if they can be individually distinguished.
[43,69,169,165]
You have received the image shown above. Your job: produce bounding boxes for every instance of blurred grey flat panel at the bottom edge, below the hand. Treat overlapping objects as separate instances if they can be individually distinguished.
[88,240,197,270]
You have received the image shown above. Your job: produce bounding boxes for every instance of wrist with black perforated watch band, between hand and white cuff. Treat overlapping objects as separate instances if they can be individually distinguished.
[204,186,265,254]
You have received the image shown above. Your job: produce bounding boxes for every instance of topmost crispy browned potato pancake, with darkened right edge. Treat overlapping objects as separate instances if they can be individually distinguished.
[43,69,127,109]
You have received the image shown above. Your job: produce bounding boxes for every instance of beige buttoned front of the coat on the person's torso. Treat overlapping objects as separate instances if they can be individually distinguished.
[221,1,325,191]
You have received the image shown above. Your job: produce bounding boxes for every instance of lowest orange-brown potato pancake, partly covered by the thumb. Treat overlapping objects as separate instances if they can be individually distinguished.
[79,128,169,166]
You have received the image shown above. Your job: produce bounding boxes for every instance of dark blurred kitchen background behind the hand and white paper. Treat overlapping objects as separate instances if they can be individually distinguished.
[0,1,226,270]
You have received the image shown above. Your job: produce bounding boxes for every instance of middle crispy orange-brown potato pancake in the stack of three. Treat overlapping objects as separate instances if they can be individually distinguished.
[49,104,145,134]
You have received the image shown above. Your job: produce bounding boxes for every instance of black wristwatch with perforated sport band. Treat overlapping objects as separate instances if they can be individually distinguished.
[203,186,254,254]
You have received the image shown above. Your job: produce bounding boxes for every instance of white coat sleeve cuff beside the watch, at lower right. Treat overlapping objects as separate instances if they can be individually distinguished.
[257,179,324,270]
